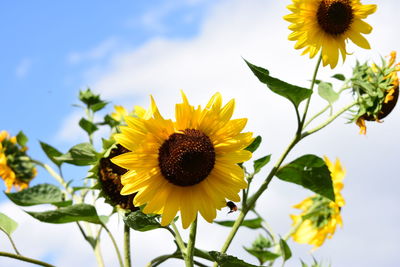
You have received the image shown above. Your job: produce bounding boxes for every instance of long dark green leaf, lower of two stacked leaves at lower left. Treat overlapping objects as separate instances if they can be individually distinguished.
[25,204,102,224]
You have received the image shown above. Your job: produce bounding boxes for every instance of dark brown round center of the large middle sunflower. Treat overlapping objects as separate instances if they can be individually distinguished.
[158,129,215,186]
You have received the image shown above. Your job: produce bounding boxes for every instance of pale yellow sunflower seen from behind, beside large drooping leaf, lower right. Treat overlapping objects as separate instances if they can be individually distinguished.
[290,157,345,250]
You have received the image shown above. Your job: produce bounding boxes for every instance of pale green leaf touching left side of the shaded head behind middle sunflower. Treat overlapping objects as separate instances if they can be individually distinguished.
[55,143,97,166]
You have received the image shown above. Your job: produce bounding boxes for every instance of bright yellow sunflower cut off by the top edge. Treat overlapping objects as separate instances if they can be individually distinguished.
[284,0,376,69]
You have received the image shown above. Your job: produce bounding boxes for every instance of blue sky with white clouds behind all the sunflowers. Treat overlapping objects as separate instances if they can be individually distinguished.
[0,0,400,267]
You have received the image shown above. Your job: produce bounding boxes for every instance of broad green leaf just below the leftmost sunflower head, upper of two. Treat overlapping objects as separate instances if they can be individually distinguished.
[5,184,71,206]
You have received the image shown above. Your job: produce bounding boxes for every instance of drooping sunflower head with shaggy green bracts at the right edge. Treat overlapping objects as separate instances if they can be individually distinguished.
[351,52,400,134]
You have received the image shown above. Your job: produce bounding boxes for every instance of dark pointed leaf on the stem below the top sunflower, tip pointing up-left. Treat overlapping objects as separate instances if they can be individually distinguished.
[244,59,312,108]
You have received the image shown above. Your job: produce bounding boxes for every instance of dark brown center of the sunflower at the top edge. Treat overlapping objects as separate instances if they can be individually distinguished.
[317,0,354,35]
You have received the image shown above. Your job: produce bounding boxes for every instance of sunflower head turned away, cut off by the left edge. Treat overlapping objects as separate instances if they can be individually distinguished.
[0,131,37,192]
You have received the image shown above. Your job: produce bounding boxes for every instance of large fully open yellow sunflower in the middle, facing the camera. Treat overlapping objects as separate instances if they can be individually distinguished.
[111,92,253,228]
